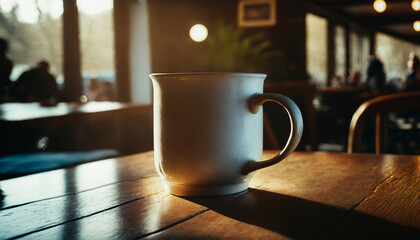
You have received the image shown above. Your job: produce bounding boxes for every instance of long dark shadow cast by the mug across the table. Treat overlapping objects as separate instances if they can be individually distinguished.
[185,189,420,239]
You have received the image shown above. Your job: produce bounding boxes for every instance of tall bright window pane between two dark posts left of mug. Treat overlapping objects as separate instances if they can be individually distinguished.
[77,0,115,101]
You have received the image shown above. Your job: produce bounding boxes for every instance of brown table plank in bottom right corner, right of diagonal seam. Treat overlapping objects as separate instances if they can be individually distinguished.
[322,157,420,239]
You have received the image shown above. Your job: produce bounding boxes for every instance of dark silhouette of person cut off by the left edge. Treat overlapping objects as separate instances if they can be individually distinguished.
[0,38,13,102]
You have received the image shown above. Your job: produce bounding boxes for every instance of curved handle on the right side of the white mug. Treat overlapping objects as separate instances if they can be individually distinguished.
[242,93,303,174]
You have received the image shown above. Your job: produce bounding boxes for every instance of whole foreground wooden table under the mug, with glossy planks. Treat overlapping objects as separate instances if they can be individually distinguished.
[0,151,420,239]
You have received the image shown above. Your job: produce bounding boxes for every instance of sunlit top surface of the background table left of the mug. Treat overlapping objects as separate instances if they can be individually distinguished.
[0,102,152,127]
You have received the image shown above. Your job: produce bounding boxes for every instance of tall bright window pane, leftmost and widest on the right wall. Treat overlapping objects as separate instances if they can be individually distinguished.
[306,14,328,86]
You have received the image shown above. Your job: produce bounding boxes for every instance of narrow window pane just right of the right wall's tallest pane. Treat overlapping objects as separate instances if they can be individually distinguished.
[334,25,347,79]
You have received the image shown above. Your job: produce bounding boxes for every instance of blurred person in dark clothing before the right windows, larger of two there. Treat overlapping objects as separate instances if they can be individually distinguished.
[366,55,386,90]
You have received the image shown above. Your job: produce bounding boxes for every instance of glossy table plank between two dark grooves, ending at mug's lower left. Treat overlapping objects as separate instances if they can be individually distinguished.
[0,177,164,239]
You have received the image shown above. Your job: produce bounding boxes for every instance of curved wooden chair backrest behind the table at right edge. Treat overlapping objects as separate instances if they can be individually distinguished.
[347,91,420,154]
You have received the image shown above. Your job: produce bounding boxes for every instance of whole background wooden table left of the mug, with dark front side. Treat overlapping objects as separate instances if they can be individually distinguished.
[0,102,153,156]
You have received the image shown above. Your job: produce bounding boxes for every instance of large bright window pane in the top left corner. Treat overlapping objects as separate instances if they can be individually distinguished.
[0,0,63,83]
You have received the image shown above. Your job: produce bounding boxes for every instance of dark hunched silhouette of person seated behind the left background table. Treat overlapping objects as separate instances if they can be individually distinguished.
[16,61,57,103]
